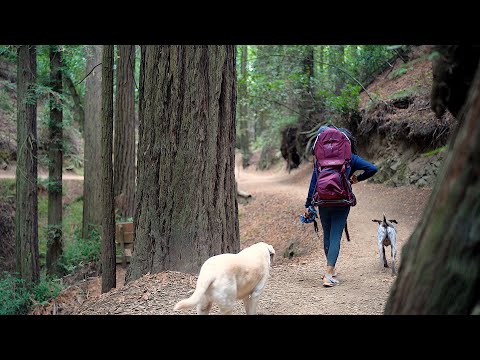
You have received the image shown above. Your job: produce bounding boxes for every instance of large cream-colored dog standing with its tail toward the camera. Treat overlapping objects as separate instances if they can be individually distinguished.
[173,242,275,315]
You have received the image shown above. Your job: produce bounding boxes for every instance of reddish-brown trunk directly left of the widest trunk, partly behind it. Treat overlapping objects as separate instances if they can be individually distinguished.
[114,45,135,219]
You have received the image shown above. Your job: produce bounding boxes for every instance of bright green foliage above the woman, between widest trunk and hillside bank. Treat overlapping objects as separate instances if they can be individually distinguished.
[237,45,403,169]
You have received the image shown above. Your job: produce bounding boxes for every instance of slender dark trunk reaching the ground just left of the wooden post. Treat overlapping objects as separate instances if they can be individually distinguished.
[98,45,116,293]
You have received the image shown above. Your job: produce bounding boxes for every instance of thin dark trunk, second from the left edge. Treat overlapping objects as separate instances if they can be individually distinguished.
[46,45,63,275]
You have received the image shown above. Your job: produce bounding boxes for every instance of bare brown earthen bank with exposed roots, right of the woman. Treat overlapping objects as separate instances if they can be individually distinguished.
[350,45,457,187]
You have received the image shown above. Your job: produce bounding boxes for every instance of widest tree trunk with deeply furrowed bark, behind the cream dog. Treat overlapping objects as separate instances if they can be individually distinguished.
[126,46,240,281]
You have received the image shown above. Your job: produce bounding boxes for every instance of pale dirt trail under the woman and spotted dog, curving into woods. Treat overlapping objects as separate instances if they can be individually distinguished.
[231,162,431,314]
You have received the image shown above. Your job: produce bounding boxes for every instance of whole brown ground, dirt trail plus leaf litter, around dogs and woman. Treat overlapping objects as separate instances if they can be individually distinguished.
[32,163,431,315]
